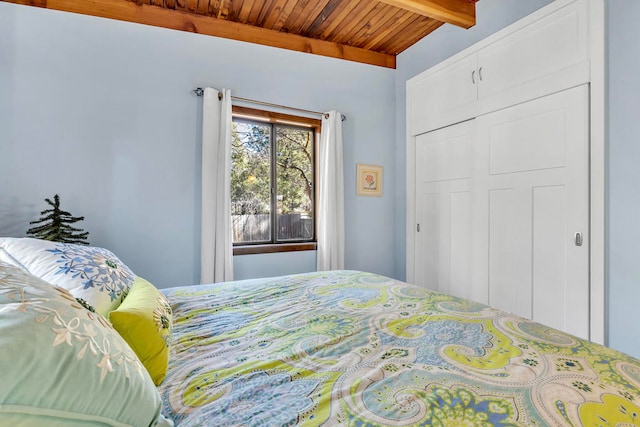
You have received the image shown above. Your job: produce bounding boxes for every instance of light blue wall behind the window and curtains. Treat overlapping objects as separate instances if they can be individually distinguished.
[0,2,396,287]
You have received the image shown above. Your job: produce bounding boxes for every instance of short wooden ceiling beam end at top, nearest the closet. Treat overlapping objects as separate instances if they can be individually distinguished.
[380,0,477,28]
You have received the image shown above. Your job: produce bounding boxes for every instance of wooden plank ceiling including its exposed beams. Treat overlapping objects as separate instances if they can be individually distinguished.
[0,0,477,68]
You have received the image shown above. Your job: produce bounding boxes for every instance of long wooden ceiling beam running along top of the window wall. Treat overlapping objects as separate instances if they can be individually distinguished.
[1,0,396,68]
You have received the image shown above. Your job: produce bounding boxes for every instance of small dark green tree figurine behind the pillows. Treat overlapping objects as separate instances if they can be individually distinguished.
[27,194,89,245]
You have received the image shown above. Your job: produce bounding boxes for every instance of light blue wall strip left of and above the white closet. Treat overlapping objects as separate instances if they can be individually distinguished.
[395,0,551,280]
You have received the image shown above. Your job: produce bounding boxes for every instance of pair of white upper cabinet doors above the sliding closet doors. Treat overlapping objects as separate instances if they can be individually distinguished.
[407,1,590,136]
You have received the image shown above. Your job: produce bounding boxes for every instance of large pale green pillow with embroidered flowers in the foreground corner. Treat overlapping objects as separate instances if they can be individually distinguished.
[0,262,170,426]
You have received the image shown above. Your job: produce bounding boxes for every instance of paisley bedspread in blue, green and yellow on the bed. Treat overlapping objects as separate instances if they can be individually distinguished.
[160,271,640,426]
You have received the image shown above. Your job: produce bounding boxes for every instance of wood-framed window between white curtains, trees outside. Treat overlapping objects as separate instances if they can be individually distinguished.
[231,106,320,255]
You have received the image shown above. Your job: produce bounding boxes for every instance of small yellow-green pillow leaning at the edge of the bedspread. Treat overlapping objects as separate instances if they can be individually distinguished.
[109,277,173,385]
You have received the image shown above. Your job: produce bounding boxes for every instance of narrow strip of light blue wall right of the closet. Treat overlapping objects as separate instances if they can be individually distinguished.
[607,0,640,358]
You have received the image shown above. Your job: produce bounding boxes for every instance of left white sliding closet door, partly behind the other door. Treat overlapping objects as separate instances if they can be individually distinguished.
[414,121,475,298]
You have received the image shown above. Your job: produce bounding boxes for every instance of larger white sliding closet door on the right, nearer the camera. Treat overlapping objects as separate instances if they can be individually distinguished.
[472,85,589,338]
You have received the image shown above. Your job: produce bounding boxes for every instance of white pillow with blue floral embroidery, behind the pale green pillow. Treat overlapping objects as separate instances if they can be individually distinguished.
[0,237,136,316]
